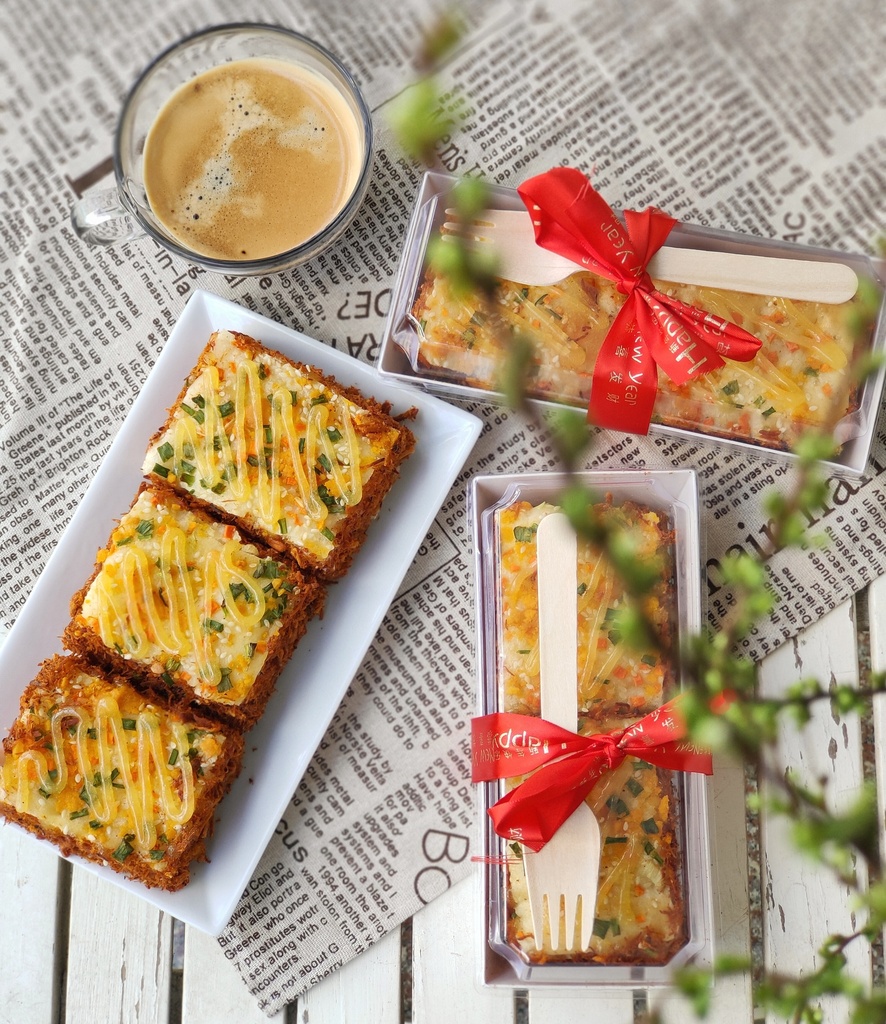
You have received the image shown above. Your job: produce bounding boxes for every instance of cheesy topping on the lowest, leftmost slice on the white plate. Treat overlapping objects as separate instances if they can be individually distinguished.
[0,673,224,862]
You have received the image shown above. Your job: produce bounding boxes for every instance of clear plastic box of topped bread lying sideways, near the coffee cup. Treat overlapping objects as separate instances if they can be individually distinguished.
[378,172,886,474]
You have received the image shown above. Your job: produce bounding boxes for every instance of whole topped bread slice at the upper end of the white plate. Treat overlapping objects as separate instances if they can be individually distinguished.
[143,331,415,579]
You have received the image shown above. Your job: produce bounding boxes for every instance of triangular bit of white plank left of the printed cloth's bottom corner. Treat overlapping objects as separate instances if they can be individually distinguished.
[181,928,286,1024]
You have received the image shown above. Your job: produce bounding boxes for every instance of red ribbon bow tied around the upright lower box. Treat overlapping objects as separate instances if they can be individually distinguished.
[471,697,713,852]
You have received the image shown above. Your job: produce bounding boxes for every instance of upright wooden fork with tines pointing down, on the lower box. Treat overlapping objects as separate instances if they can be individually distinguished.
[523,512,600,950]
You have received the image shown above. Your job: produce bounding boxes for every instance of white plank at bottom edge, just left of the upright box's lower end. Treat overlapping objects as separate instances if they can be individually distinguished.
[412,879,514,1024]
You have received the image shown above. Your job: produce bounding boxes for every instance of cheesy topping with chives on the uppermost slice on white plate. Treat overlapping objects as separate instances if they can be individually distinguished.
[144,331,398,558]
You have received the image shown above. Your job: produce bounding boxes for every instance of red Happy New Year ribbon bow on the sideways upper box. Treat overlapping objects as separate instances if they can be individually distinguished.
[517,167,761,434]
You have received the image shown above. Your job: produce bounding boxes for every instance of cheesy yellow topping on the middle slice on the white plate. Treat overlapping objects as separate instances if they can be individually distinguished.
[82,490,292,703]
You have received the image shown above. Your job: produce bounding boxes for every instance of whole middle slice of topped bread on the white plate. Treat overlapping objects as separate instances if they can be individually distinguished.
[64,486,325,728]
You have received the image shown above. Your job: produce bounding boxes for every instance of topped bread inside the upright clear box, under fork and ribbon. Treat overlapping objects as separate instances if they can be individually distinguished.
[495,500,687,965]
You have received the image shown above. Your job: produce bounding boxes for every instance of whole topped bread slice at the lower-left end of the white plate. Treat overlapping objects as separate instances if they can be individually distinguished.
[0,655,244,891]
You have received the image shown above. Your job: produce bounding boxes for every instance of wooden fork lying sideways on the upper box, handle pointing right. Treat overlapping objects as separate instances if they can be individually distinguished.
[442,209,858,303]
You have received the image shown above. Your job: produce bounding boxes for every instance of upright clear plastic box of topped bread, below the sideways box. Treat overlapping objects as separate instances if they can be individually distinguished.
[471,470,713,988]
